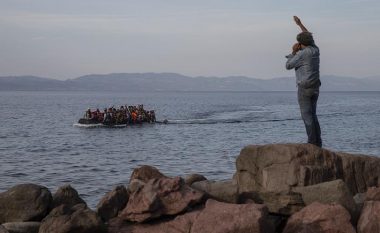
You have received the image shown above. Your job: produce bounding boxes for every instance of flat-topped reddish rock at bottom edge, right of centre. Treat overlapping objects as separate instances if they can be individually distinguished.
[191,199,274,233]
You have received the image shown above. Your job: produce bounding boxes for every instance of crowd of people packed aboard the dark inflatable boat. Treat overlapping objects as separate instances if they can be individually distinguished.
[84,104,156,125]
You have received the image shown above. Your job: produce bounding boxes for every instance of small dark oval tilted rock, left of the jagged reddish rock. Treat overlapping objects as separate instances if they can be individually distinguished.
[96,185,129,222]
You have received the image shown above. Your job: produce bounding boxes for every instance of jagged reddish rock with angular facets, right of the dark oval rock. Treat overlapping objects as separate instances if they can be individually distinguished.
[119,177,204,222]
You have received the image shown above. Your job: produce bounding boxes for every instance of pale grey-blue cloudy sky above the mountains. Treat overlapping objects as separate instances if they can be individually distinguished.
[0,0,380,80]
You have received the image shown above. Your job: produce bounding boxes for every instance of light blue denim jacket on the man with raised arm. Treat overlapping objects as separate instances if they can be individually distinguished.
[286,45,321,88]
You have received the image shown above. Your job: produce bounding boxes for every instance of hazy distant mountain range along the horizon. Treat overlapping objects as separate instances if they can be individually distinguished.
[0,73,380,91]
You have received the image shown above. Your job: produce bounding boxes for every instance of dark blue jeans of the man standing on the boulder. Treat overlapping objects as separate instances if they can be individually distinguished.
[298,87,322,147]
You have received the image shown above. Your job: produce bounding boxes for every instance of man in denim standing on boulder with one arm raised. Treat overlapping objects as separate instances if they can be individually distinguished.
[286,16,322,147]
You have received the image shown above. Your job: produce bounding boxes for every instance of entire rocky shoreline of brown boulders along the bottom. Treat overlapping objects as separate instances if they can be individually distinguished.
[0,144,380,233]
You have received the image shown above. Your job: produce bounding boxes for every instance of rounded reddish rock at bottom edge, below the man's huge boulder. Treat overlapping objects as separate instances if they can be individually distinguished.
[283,202,356,233]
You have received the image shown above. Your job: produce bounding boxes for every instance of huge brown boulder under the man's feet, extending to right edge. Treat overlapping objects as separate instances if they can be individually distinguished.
[235,144,380,194]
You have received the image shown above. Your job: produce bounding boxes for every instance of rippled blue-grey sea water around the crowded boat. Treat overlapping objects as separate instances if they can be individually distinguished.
[0,92,380,207]
